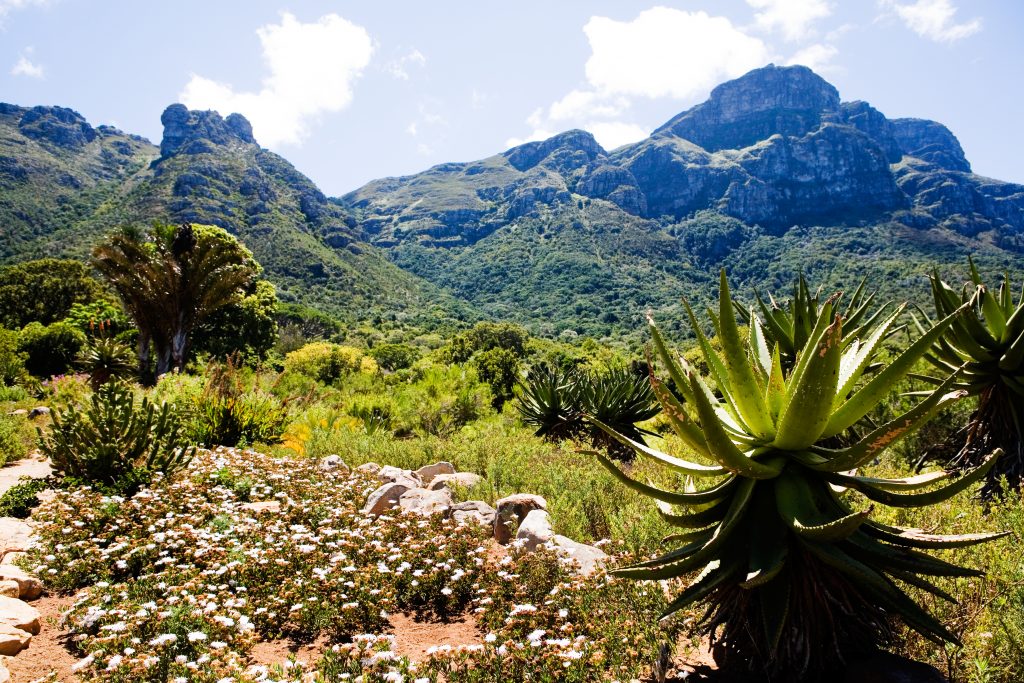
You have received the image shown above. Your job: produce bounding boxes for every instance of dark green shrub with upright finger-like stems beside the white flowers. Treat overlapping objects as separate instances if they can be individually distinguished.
[39,383,195,495]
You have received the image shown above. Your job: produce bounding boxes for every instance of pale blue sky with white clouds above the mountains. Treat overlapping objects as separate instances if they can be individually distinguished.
[0,0,1024,196]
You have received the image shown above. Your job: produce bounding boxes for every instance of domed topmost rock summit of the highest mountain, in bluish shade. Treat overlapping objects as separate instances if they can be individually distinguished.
[653,65,840,152]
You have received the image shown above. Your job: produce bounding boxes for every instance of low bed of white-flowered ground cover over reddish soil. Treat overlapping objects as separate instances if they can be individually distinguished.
[26,449,667,681]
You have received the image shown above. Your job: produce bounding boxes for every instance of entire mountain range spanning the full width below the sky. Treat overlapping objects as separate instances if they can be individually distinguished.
[0,66,1024,338]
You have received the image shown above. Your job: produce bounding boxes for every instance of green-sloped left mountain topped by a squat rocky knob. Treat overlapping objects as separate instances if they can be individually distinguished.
[0,100,468,321]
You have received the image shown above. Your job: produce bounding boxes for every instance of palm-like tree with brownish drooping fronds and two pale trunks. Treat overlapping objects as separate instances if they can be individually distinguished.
[93,223,260,377]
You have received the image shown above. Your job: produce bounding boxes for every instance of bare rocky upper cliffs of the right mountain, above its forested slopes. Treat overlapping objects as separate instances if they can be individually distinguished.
[342,66,1024,242]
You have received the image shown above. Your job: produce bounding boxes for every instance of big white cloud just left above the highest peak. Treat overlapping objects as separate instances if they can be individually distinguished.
[584,7,770,99]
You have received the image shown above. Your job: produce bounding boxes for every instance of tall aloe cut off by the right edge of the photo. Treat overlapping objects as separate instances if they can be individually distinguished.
[923,260,1024,498]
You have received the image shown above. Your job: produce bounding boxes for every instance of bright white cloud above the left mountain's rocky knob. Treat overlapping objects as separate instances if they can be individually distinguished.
[179,12,374,147]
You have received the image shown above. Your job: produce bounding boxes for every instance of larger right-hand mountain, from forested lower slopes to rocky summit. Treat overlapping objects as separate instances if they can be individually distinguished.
[339,66,1024,335]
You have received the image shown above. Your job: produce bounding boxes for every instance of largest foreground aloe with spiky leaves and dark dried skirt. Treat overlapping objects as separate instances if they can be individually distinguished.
[594,271,1001,680]
